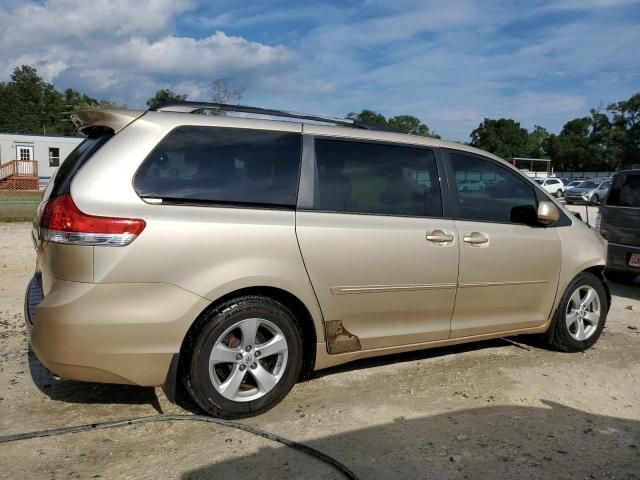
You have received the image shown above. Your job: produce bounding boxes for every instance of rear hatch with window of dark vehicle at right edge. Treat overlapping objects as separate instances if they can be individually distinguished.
[600,171,640,247]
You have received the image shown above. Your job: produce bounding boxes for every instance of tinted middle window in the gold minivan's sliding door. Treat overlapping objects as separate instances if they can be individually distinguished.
[314,138,442,217]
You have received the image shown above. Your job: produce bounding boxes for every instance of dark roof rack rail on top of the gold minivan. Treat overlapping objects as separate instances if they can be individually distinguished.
[149,100,393,132]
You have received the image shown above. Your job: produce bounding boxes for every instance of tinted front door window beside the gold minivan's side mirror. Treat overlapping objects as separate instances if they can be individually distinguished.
[449,152,538,223]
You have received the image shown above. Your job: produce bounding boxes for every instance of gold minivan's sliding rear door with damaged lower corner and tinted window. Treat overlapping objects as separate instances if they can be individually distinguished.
[296,137,458,353]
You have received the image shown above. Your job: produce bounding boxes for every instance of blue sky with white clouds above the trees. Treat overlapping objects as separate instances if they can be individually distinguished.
[0,0,640,141]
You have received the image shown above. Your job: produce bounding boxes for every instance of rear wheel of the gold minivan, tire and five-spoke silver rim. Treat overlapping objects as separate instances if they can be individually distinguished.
[185,295,302,418]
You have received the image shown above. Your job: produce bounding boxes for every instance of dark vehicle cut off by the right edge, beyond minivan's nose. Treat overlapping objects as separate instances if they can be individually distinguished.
[596,170,640,283]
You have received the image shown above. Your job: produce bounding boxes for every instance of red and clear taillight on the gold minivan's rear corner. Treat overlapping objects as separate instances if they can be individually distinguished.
[40,194,146,247]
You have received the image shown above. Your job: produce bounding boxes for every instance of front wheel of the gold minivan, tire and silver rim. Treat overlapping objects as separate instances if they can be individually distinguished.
[546,272,609,352]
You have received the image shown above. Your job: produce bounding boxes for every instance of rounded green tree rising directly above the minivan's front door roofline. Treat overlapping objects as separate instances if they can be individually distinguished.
[471,118,530,158]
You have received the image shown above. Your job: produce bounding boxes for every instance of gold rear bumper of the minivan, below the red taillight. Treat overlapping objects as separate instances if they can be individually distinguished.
[25,276,209,386]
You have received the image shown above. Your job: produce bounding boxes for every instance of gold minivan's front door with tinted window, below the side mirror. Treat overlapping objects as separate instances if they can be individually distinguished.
[443,150,560,338]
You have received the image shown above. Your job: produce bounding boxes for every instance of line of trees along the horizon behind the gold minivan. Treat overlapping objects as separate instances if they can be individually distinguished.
[0,65,640,171]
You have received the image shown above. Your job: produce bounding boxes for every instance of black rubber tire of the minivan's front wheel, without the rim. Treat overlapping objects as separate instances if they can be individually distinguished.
[545,272,609,352]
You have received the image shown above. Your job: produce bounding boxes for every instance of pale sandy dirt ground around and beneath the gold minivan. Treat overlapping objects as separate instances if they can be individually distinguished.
[0,223,640,479]
